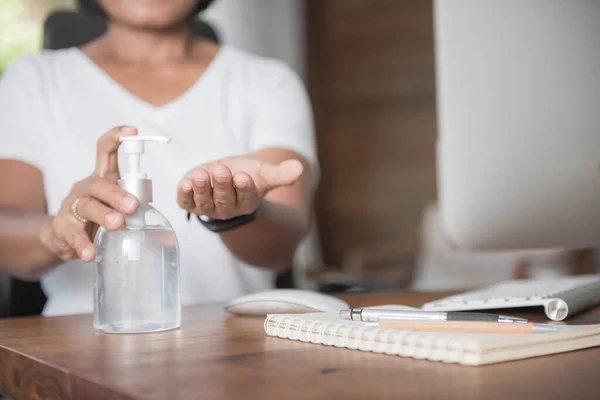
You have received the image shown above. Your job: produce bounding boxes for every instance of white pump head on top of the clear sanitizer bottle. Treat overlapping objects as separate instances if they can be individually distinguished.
[119,136,171,204]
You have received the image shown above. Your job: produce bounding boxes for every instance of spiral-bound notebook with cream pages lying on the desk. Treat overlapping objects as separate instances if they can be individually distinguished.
[264,306,600,366]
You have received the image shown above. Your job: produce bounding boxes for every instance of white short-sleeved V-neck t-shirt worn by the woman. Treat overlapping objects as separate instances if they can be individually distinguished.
[0,47,318,315]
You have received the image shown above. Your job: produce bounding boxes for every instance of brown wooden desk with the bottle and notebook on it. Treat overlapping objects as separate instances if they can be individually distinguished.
[0,293,600,400]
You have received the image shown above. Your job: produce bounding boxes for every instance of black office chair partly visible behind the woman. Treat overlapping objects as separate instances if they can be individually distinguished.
[0,10,219,318]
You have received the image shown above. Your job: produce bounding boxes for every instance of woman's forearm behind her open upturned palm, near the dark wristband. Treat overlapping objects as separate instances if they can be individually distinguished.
[220,200,310,270]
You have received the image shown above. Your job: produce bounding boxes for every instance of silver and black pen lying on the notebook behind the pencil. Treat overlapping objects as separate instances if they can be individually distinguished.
[340,308,527,323]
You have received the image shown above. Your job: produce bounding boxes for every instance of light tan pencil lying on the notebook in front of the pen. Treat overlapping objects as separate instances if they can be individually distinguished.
[367,319,556,334]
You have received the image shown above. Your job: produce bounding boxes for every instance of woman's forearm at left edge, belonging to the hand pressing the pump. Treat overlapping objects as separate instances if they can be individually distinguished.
[0,208,60,279]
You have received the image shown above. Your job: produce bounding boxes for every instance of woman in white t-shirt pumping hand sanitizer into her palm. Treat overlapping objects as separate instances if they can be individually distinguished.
[0,0,317,315]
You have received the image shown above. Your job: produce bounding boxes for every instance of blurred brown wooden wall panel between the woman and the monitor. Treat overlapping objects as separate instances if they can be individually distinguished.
[306,0,437,265]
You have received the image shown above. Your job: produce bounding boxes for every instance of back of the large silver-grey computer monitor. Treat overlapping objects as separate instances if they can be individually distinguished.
[434,0,600,251]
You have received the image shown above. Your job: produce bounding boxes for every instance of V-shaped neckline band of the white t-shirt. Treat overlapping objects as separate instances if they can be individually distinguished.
[72,47,225,121]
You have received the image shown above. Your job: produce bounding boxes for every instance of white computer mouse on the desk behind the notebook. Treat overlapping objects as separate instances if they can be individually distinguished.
[225,289,349,316]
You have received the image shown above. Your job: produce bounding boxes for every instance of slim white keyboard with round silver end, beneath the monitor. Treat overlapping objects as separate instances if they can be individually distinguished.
[422,275,600,321]
